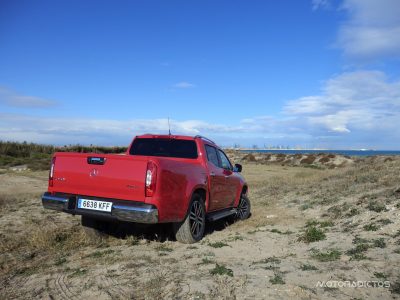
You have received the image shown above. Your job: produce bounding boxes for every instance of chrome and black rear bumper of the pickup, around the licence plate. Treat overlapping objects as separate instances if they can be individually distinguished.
[42,192,158,224]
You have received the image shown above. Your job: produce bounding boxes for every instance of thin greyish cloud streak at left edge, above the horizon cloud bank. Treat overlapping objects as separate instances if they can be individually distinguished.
[0,87,57,108]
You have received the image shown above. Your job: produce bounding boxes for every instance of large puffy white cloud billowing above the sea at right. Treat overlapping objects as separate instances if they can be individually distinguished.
[284,71,400,135]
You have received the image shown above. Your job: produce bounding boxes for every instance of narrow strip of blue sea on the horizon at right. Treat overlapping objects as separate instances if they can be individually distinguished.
[241,149,400,156]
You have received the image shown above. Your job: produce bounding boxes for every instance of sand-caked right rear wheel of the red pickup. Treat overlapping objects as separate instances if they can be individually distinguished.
[174,194,206,244]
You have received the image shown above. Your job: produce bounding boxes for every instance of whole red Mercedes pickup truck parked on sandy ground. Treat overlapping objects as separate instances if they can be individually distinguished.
[42,134,250,243]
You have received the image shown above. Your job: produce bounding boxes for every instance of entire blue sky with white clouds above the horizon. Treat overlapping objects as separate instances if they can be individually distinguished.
[0,0,400,149]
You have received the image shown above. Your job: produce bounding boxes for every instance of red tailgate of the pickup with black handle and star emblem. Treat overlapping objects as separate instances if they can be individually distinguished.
[52,152,147,201]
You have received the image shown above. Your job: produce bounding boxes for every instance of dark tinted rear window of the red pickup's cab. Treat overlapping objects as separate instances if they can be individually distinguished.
[129,138,197,158]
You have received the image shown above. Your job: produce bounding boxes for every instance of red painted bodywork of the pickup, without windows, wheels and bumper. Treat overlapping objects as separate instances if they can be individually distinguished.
[48,135,247,222]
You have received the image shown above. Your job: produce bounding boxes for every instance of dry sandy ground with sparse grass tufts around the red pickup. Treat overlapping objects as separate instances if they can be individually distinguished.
[0,157,400,300]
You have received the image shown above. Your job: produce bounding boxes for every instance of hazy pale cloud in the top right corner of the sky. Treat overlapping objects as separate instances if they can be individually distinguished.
[337,0,400,60]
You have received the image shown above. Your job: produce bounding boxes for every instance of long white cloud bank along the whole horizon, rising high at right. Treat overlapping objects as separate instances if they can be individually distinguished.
[0,71,400,148]
